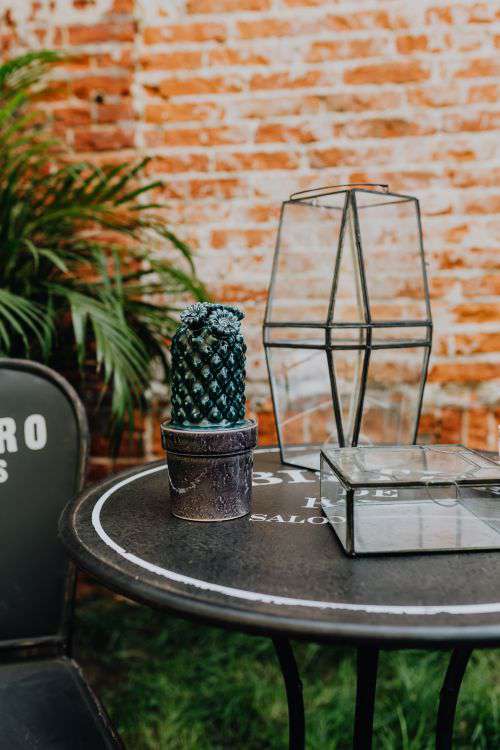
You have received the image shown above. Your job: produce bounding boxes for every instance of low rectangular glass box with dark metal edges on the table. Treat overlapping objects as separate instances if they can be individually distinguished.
[320,445,500,555]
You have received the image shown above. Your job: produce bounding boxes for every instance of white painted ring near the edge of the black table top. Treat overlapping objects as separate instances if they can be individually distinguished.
[92,448,500,615]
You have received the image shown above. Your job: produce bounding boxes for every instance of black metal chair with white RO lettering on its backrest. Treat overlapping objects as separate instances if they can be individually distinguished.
[0,359,122,750]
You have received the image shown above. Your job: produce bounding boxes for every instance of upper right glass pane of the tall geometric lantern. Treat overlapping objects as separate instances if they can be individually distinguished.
[355,191,427,320]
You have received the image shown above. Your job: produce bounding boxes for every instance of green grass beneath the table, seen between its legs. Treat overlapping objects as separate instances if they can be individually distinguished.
[76,592,500,750]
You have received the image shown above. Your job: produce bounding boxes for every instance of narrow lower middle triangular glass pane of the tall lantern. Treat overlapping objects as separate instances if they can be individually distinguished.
[332,349,364,445]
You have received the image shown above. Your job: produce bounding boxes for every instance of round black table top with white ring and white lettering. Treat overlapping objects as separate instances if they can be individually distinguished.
[60,448,500,648]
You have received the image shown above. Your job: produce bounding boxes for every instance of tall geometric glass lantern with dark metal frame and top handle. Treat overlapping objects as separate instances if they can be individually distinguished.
[263,184,432,470]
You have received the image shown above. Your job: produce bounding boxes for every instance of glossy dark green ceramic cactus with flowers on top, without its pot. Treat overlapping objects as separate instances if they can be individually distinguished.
[172,302,246,427]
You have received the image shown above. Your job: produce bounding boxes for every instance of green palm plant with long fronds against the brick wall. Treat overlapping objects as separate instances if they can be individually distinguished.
[0,51,206,450]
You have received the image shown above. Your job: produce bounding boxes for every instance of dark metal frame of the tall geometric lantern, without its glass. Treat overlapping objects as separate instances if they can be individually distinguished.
[263,183,433,468]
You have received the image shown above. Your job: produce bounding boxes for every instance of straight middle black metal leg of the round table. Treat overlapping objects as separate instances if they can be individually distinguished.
[353,647,379,750]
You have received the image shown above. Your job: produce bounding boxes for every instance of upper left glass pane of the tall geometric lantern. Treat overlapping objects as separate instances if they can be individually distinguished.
[268,193,345,323]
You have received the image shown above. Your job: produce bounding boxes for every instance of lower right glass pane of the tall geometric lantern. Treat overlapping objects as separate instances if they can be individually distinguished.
[358,347,427,444]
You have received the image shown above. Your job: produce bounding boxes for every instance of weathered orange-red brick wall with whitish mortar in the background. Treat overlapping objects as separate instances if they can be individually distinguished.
[0,0,500,470]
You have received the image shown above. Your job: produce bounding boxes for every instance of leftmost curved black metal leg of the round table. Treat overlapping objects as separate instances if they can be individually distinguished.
[272,636,306,750]
